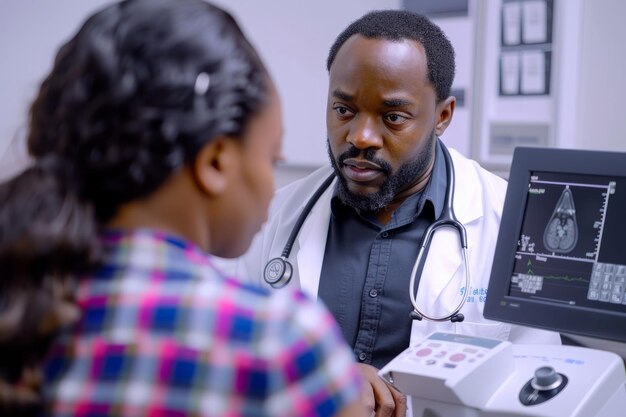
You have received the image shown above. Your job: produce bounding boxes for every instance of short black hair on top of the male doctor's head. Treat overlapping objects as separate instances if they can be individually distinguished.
[326,10,455,101]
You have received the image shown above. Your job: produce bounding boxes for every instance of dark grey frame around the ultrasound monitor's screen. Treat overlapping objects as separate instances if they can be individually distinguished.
[483,147,626,342]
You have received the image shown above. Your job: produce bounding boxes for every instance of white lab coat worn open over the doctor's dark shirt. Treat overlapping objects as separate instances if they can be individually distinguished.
[225,149,560,344]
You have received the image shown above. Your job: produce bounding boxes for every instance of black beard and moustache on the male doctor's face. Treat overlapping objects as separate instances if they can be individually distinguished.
[326,129,437,212]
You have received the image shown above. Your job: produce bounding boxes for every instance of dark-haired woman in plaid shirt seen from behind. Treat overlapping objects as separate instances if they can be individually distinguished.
[0,0,365,417]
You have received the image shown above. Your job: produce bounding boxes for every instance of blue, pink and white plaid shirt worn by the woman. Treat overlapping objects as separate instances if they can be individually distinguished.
[44,230,360,417]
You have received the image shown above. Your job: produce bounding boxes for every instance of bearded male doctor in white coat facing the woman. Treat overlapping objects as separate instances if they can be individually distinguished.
[227,10,560,416]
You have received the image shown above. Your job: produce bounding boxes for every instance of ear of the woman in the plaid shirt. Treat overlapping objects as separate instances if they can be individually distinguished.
[192,136,239,195]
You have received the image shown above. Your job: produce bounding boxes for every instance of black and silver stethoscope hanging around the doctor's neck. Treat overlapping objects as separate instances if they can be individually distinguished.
[263,141,470,323]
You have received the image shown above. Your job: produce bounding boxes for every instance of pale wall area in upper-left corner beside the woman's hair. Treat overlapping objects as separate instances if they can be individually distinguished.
[0,0,114,179]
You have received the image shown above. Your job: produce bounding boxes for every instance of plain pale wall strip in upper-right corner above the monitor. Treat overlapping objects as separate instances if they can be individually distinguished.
[555,0,626,152]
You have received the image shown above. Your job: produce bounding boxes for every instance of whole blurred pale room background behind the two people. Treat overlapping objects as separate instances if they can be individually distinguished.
[0,0,626,187]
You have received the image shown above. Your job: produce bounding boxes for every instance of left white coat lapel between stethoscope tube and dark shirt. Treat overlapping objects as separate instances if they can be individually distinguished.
[296,180,336,298]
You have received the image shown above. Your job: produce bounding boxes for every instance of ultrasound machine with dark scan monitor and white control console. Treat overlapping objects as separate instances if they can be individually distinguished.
[379,148,626,417]
